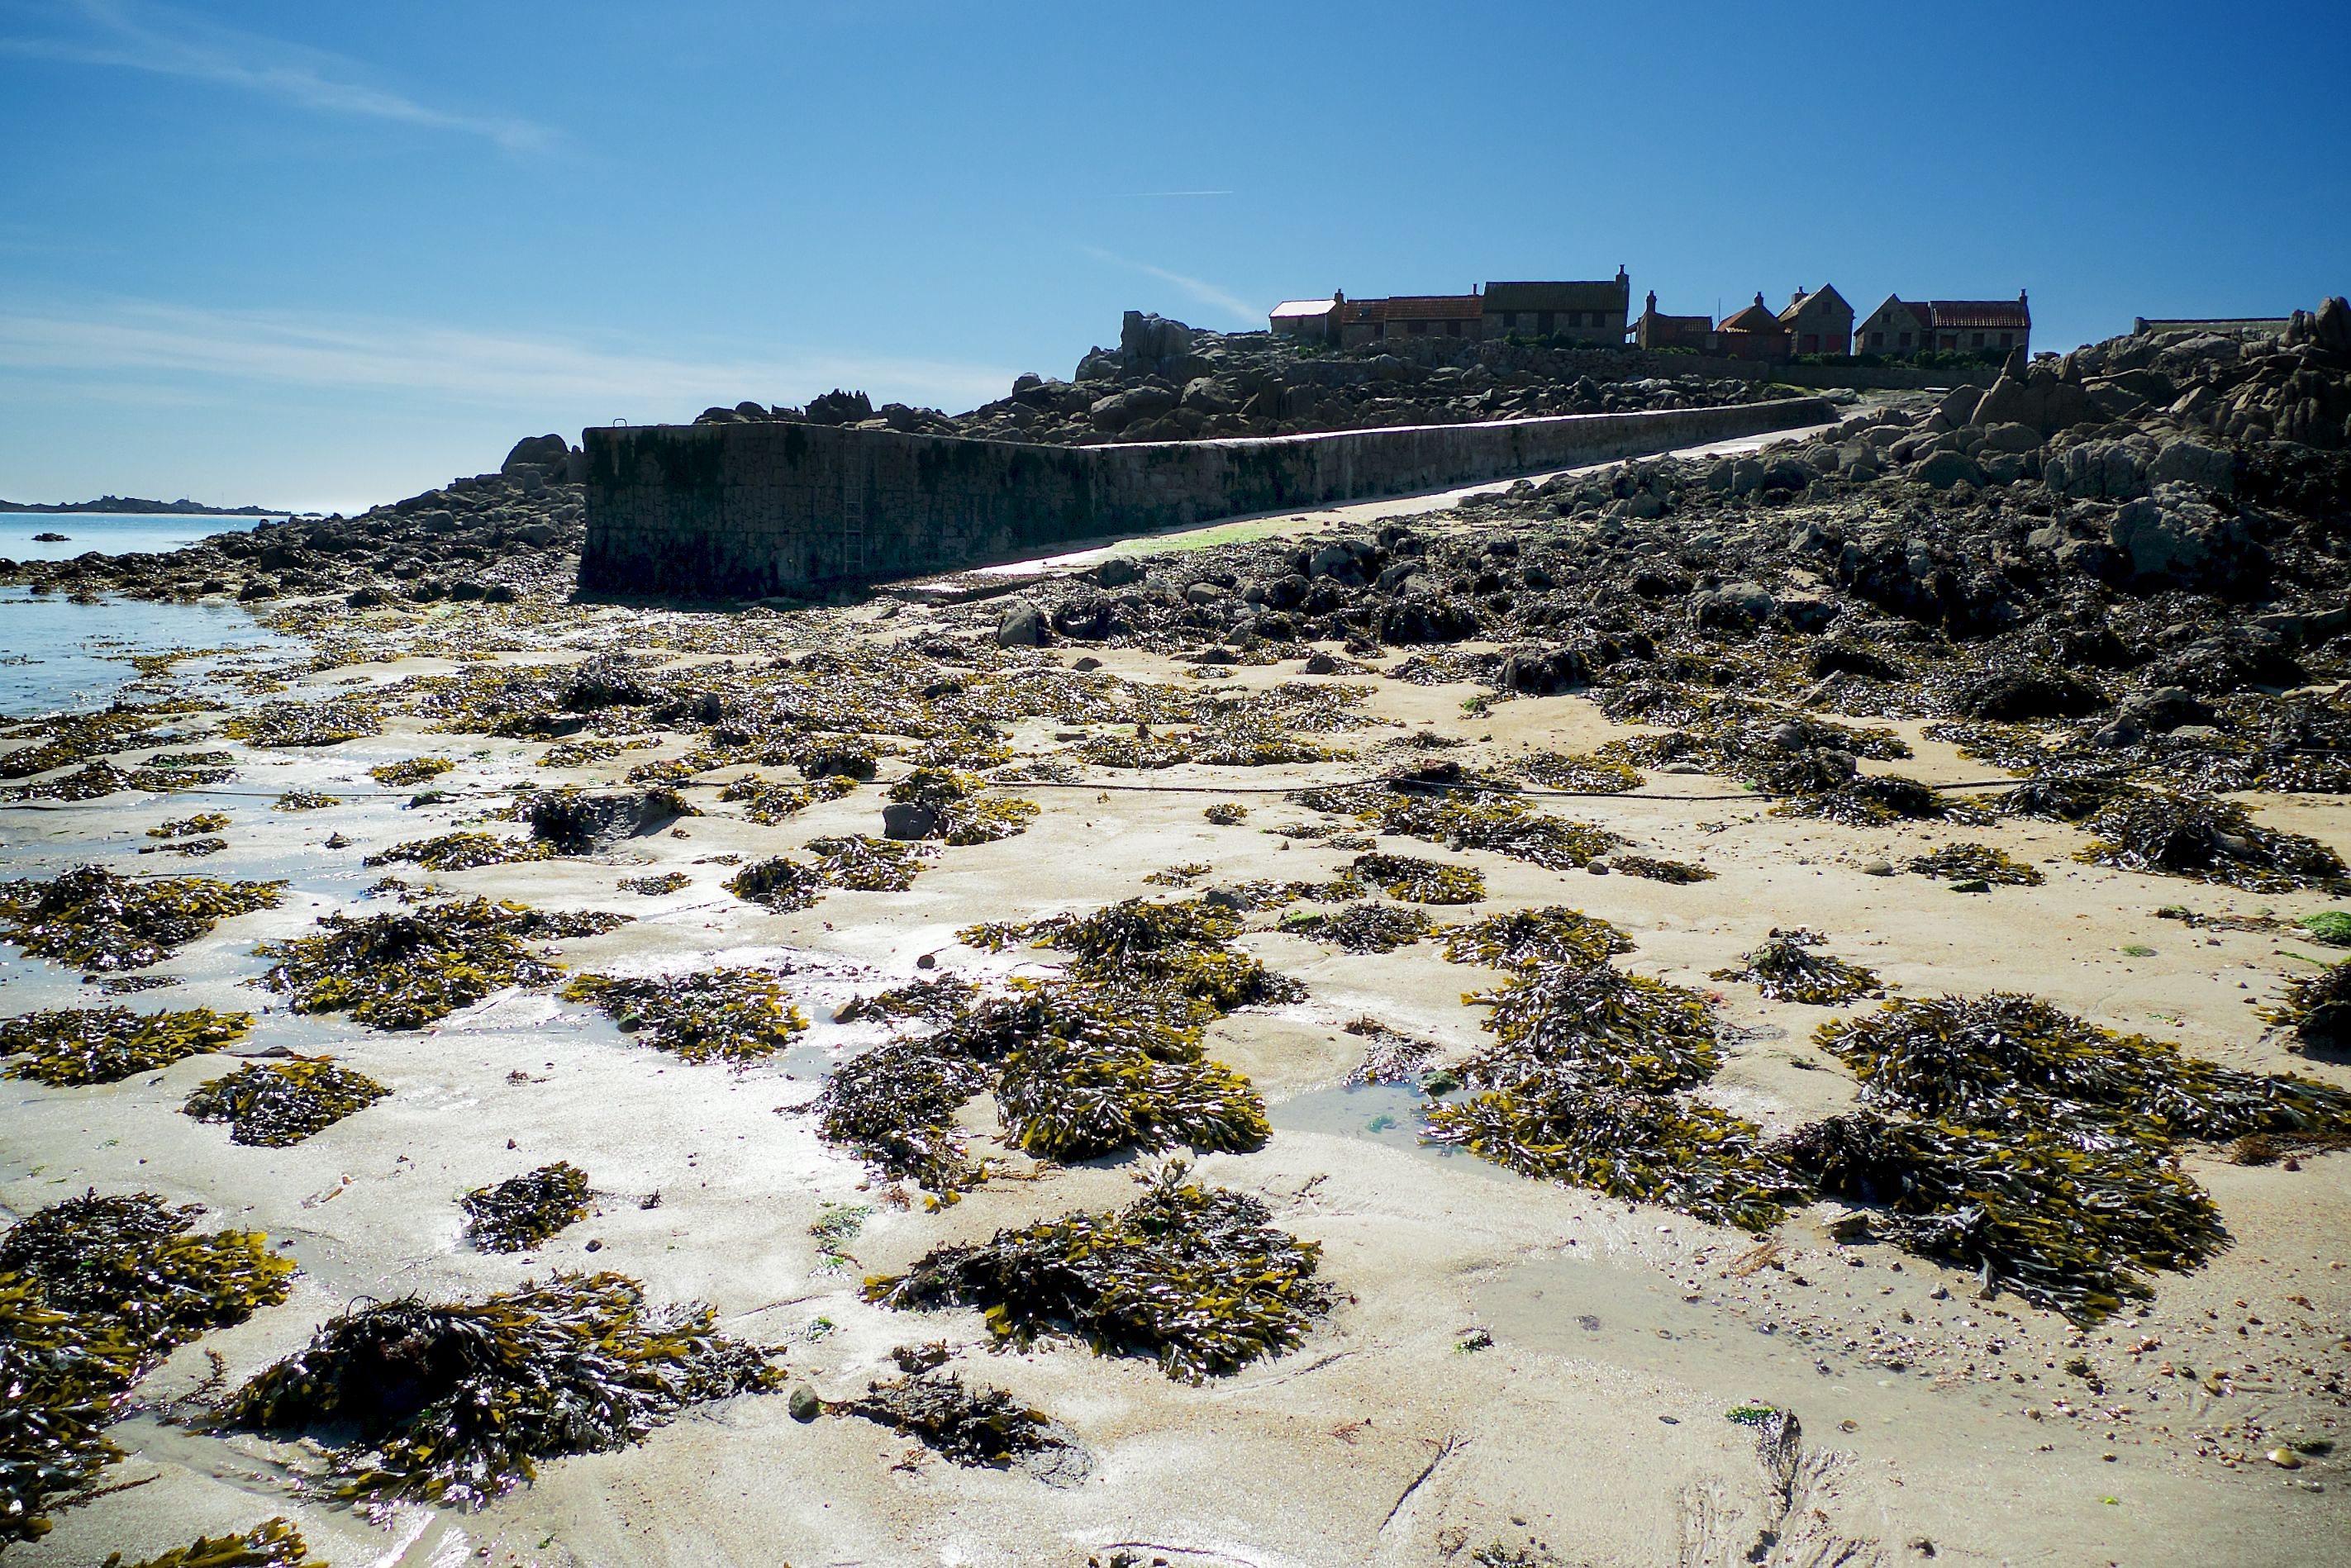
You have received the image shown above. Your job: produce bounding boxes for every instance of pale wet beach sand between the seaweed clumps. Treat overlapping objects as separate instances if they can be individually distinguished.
[0,474,2351,1568]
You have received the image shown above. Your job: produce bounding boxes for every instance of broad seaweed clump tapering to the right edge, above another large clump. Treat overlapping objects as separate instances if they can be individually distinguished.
[1815,992,2351,1152]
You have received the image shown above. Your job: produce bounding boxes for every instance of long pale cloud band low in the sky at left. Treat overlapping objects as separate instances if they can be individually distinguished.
[0,303,1011,419]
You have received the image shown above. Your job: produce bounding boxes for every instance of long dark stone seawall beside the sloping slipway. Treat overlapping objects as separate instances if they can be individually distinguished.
[581,397,1834,600]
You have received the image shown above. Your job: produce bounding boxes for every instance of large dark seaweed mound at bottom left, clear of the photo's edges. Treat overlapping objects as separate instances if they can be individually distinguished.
[223,1274,781,1507]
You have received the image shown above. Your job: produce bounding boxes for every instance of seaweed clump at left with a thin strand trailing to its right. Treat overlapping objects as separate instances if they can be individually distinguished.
[254,898,630,1029]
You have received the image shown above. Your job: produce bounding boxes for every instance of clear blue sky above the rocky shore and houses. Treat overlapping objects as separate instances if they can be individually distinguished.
[0,0,2351,508]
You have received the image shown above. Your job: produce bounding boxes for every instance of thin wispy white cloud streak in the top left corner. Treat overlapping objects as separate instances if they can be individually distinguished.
[0,0,554,153]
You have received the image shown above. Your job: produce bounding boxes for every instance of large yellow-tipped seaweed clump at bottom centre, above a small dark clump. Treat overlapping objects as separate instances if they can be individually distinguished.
[865,1162,1333,1382]
